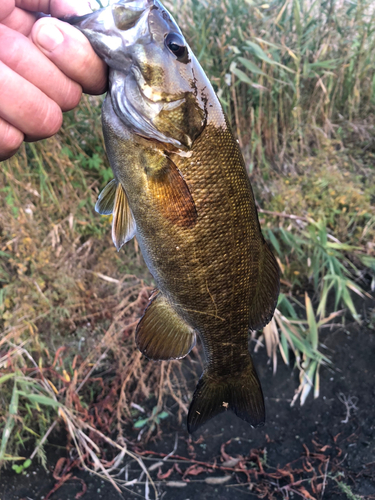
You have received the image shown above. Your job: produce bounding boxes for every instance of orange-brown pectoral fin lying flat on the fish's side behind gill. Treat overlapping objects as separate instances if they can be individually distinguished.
[147,156,198,227]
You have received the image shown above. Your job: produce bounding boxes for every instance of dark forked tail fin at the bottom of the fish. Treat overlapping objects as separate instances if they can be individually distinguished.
[187,355,265,434]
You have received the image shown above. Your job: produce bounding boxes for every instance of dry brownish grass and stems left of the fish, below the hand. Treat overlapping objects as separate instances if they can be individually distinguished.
[0,99,203,463]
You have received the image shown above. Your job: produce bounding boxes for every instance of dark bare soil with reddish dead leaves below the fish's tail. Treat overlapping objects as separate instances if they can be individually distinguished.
[0,310,375,500]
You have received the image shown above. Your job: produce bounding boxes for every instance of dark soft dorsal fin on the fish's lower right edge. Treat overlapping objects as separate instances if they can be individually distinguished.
[249,241,280,330]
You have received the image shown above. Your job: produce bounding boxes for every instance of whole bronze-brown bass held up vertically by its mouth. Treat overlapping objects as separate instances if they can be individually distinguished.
[69,0,280,433]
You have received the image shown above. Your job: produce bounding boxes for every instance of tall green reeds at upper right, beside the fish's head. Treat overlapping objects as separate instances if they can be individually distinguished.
[171,0,375,170]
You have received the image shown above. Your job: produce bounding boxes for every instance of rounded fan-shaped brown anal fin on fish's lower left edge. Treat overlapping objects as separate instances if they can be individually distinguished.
[135,291,196,360]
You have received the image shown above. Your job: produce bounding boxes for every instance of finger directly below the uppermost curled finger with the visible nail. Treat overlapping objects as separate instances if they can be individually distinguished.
[0,25,82,111]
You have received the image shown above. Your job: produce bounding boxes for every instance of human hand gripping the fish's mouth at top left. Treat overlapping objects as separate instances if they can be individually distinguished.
[0,0,107,161]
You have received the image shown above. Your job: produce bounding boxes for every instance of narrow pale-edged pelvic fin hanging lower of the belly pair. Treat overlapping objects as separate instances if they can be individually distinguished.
[112,184,136,250]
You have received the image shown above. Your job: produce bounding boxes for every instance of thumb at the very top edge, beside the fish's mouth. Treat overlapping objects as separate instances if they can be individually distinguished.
[14,0,91,17]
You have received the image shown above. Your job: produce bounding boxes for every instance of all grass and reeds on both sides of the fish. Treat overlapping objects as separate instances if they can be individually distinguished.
[0,0,375,492]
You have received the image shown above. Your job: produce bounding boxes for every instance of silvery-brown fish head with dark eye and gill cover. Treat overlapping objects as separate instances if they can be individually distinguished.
[71,0,211,151]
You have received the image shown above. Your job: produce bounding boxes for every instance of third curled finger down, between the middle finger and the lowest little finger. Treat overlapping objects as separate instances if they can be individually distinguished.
[0,61,62,141]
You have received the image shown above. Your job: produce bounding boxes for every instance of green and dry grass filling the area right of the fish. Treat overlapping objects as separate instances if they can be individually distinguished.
[171,0,375,403]
